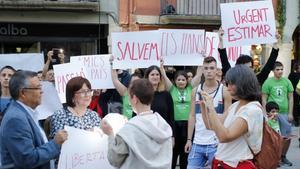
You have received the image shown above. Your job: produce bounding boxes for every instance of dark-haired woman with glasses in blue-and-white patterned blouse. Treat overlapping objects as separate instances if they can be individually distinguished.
[50,77,100,137]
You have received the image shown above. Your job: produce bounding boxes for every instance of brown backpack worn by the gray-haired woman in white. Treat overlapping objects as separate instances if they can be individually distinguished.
[249,121,283,169]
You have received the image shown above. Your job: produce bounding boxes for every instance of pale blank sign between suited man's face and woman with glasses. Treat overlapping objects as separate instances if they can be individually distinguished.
[36,81,62,120]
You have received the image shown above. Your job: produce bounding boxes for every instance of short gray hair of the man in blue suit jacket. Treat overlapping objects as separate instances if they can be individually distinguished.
[9,70,37,100]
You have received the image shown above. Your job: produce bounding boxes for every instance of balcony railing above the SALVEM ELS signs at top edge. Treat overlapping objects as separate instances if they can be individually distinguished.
[160,0,249,16]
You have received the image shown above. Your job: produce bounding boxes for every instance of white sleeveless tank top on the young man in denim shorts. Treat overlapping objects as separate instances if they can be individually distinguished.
[193,83,224,145]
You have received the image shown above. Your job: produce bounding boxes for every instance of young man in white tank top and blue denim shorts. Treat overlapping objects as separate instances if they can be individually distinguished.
[185,57,232,169]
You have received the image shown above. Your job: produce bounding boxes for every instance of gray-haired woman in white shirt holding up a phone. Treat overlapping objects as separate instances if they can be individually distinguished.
[199,65,263,169]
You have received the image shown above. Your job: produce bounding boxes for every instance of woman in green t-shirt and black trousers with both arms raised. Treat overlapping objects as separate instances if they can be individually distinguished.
[160,60,202,169]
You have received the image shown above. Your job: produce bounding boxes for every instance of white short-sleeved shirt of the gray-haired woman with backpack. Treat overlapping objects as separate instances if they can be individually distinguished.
[215,101,264,167]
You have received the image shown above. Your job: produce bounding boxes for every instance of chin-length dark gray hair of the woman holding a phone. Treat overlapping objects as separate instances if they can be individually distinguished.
[225,65,261,101]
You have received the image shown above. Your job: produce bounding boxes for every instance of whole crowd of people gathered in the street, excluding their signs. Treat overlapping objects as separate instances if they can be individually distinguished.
[0,30,300,169]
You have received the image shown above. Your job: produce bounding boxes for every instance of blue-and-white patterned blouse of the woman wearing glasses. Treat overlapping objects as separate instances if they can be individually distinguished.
[50,108,100,137]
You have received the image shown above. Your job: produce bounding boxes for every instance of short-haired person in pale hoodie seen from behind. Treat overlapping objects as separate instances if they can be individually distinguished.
[102,79,172,169]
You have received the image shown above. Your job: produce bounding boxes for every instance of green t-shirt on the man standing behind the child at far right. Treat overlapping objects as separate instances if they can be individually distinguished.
[262,77,294,114]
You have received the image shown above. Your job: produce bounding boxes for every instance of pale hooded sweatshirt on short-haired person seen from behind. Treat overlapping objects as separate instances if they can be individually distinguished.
[108,113,172,169]
